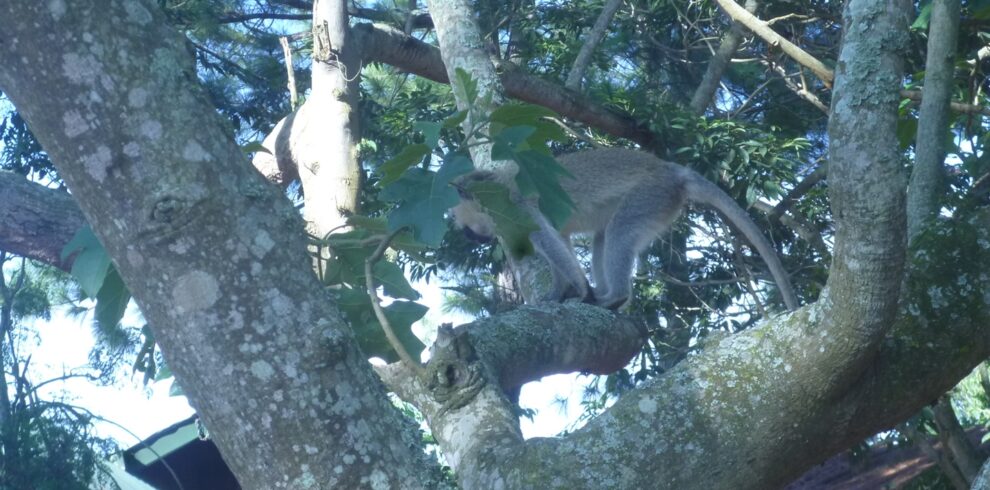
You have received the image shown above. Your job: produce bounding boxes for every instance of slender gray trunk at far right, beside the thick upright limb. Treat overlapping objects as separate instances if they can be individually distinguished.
[907,0,959,237]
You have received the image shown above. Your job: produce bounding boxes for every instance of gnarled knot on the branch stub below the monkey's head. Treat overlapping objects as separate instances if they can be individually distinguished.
[425,323,487,415]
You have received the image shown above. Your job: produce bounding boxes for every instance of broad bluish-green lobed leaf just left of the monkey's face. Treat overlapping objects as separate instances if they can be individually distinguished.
[381,154,473,247]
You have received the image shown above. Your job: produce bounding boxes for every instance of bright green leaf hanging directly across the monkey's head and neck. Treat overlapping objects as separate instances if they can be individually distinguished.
[467,181,539,258]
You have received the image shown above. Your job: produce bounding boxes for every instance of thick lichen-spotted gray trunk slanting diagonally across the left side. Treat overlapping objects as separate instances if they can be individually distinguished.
[0,0,431,489]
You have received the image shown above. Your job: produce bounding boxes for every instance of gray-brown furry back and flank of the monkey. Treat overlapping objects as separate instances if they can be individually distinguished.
[557,148,684,234]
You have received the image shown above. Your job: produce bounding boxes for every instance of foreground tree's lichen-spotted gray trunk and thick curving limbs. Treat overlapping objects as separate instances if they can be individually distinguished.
[0,0,990,489]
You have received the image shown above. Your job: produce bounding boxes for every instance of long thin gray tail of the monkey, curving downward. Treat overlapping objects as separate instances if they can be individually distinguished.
[685,170,799,310]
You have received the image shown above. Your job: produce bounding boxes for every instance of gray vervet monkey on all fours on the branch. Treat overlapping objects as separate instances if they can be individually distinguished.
[451,148,798,310]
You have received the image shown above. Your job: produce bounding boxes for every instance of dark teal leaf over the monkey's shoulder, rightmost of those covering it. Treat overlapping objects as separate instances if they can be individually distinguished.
[515,150,574,229]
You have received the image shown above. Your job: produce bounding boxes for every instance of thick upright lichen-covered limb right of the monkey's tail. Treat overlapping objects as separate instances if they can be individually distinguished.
[818,0,911,389]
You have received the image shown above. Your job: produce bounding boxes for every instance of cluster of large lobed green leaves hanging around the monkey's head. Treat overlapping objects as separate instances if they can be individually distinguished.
[328,73,573,361]
